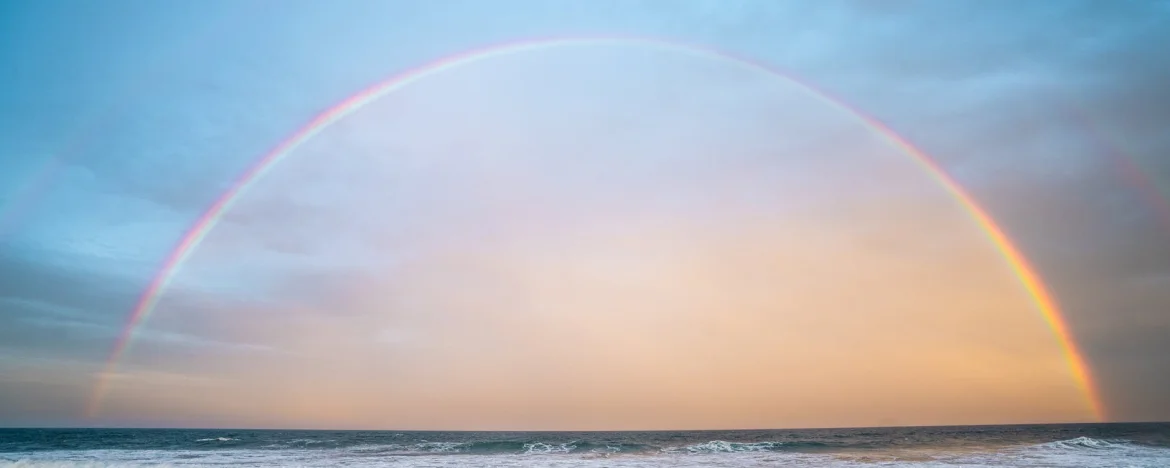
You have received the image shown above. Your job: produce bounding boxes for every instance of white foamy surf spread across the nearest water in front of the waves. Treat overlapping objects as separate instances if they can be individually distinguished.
[0,438,1170,468]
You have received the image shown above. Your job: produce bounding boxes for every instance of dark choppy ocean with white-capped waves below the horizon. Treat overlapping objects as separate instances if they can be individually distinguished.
[0,424,1170,467]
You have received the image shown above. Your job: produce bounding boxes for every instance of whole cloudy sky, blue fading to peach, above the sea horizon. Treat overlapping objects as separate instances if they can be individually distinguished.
[0,0,1170,429]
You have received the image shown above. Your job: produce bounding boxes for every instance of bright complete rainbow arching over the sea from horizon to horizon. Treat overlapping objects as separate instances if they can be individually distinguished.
[87,36,1104,420]
